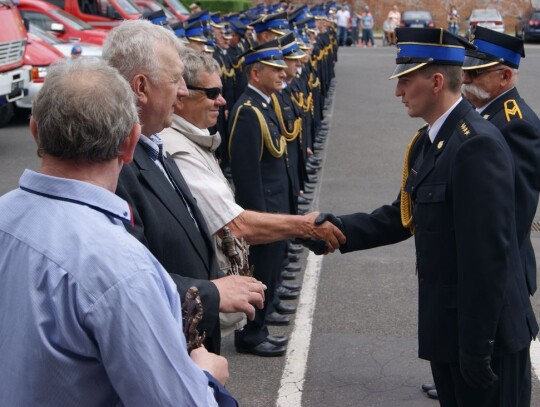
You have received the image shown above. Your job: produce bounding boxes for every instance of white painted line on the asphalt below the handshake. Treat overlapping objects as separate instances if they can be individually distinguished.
[276,252,323,407]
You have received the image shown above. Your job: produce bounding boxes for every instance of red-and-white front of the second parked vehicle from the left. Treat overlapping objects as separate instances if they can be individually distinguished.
[15,29,65,109]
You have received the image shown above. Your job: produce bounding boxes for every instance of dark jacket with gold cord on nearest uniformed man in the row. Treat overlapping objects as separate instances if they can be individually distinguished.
[229,87,294,213]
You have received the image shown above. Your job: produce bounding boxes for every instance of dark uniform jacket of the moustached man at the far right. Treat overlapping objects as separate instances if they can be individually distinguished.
[482,88,540,295]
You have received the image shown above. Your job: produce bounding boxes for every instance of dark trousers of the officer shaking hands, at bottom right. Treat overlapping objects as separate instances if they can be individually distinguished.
[431,347,531,407]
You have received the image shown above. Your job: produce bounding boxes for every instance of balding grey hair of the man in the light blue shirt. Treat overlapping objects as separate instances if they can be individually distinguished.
[32,57,138,163]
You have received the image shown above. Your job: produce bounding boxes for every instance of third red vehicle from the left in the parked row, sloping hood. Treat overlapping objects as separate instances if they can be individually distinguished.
[18,0,107,45]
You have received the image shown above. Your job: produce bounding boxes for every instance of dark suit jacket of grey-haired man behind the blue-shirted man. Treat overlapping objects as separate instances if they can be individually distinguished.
[116,144,220,353]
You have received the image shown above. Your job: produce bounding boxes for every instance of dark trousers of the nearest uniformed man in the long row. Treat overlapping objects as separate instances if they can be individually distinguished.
[235,241,286,346]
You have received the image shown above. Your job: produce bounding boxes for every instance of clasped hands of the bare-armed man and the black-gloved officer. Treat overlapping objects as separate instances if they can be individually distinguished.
[296,213,346,255]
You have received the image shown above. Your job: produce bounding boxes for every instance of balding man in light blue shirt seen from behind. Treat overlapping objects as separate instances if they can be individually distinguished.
[0,59,236,407]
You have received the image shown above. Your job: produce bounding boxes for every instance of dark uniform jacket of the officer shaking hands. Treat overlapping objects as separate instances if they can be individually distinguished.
[341,100,538,362]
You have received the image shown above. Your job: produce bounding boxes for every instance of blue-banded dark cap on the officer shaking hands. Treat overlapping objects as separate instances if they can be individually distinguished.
[389,28,476,79]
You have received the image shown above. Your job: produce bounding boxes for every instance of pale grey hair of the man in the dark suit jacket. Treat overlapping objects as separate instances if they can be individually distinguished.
[103,20,184,83]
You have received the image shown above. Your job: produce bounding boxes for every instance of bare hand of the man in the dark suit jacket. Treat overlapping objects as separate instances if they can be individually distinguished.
[212,275,266,320]
